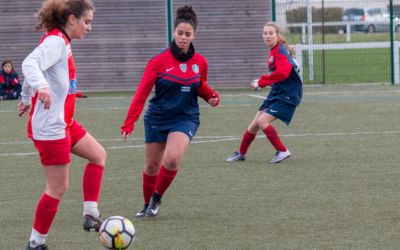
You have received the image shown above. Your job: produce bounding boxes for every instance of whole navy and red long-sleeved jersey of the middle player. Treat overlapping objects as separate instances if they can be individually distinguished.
[122,43,218,132]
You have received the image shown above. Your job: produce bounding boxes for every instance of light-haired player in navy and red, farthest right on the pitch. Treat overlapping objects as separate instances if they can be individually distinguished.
[226,22,303,163]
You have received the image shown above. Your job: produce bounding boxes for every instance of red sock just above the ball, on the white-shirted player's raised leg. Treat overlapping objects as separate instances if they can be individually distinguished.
[82,163,104,202]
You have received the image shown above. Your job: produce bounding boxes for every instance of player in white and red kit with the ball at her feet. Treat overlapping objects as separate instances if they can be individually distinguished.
[18,0,106,249]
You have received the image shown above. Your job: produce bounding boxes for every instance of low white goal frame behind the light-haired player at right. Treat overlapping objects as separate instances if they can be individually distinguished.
[295,41,400,84]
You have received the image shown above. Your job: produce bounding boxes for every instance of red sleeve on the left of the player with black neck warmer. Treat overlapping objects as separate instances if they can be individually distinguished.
[121,58,158,133]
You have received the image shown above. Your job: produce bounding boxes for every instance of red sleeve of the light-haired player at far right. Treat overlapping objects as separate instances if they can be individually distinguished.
[258,50,292,88]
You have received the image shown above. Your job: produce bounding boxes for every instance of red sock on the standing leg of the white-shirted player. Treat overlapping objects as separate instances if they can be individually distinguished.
[33,193,60,234]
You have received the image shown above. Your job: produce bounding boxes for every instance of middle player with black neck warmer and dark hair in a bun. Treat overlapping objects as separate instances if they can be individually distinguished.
[121,6,219,217]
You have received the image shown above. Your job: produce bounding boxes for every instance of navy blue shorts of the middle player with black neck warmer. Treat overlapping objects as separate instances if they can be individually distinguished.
[144,119,199,143]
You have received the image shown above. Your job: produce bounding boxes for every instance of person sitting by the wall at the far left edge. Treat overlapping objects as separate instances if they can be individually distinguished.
[0,60,22,100]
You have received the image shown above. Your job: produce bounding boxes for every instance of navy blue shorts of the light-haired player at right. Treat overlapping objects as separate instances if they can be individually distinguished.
[258,99,296,125]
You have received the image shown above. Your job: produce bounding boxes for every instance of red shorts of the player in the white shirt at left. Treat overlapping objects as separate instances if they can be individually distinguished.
[32,120,86,166]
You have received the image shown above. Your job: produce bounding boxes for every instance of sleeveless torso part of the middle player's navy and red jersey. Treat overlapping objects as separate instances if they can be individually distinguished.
[145,50,203,124]
